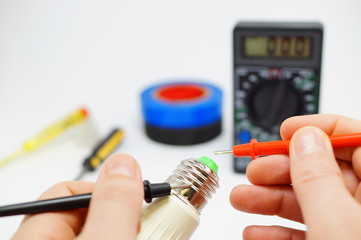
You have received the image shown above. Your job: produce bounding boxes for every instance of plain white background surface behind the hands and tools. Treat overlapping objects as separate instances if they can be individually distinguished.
[0,0,361,239]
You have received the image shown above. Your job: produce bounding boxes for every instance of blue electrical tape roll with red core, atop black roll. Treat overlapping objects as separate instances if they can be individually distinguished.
[141,80,222,129]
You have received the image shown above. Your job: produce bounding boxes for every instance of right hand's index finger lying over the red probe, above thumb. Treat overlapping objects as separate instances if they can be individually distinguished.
[280,114,361,161]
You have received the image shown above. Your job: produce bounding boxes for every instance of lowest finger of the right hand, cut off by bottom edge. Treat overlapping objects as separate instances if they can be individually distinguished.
[243,226,305,240]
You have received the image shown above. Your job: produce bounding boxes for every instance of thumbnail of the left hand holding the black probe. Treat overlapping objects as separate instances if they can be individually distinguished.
[107,159,136,177]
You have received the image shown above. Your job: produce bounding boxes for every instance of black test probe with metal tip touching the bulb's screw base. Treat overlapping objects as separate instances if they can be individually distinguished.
[0,180,190,217]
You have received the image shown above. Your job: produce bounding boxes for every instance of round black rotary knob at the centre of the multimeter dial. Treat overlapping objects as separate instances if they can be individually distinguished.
[247,80,303,132]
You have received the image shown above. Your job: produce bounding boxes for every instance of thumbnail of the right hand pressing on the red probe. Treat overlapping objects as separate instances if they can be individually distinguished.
[295,127,326,155]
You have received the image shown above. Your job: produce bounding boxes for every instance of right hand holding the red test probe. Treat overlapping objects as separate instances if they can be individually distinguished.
[230,115,361,240]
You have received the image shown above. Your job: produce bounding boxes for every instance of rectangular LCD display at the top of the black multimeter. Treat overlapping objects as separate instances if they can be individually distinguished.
[243,36,312,58]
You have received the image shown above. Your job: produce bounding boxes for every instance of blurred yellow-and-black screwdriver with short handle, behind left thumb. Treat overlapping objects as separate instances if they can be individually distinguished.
[75,128,124,180]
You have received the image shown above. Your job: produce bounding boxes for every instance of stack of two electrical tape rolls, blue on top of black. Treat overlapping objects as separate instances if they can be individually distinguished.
[141,79,222,145]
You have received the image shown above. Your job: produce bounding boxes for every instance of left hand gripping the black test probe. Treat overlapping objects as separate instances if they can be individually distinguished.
[13,154,144,240]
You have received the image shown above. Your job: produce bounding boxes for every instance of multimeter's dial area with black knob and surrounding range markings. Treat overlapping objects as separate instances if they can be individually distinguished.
[235,67,317,141]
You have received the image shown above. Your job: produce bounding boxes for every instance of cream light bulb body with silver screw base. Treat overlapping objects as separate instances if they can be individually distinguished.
[137,158,218,240]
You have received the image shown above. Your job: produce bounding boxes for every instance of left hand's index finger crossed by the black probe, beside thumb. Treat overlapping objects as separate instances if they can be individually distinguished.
[13,182,94,240]
